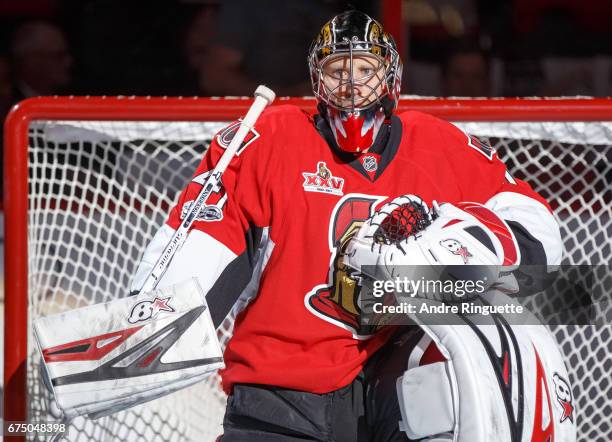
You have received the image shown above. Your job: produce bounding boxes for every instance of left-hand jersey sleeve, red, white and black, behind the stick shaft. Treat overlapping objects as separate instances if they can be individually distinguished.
[131,123,272,326]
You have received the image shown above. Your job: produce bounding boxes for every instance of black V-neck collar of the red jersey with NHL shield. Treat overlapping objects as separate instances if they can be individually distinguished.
[315,115,402,181]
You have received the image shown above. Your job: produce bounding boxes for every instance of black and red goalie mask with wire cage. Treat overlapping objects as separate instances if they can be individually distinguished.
[308,11,402,153]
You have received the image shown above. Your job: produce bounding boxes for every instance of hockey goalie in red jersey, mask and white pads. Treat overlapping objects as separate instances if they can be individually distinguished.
[39,7,575,442]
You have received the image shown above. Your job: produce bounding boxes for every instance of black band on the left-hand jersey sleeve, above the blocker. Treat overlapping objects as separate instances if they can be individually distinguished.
[206,226,263,328]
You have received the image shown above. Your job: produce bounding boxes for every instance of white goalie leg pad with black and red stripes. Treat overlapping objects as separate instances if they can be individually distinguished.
[396,292,576,442]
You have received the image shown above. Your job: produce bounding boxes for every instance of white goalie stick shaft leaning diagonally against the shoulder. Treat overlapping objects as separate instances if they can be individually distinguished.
[139,85,276,293]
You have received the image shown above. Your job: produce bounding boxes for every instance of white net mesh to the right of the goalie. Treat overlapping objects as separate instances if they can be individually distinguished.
[460,122,612,442]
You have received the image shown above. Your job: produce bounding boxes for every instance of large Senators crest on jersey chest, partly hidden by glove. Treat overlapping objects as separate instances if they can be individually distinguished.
[304,193,385,339]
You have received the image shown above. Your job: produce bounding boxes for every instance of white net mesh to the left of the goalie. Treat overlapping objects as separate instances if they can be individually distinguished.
[28,122,230,441]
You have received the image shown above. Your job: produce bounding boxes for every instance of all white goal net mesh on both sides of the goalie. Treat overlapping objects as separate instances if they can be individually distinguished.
[19,115,612,441]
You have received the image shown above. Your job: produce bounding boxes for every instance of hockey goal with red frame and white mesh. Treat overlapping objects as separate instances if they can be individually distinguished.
[4,98,612,441]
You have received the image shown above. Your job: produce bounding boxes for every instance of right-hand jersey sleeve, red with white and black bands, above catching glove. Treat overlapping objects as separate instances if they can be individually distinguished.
[440,117,562,266]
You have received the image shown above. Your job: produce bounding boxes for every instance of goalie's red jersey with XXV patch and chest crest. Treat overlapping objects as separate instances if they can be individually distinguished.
[131,106,557,393]
